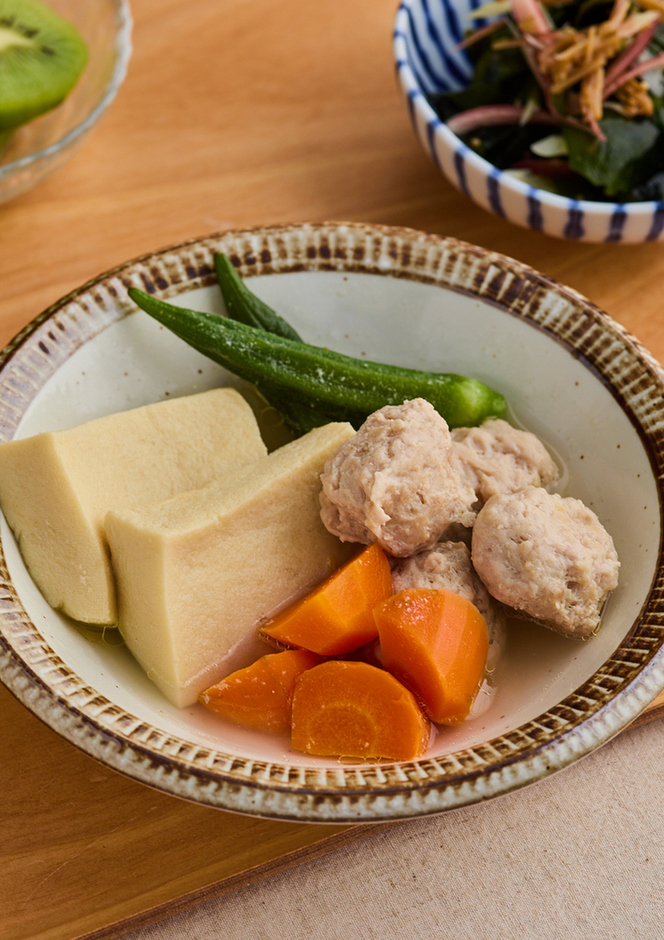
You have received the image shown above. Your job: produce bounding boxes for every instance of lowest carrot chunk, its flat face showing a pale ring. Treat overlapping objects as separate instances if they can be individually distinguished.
[291,659,431,760]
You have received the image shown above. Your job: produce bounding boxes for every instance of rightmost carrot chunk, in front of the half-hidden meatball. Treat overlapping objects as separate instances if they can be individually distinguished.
[374,588,489,724]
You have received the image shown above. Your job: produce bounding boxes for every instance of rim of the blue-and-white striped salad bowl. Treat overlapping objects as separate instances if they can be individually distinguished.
[392,0,664,217]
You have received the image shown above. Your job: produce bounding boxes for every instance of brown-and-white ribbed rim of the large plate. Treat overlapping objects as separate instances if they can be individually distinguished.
[0,222,664,823]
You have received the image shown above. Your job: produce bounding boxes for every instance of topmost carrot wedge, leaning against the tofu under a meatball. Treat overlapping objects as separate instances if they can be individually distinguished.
[261,543,392,656]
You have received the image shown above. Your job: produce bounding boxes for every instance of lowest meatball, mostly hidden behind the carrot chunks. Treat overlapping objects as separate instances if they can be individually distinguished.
[392,541,505,672]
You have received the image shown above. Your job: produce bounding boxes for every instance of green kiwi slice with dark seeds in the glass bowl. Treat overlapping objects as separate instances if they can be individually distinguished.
[0,0,88,132]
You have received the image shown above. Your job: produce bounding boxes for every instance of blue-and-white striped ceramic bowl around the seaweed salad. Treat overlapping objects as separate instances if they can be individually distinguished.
[394,0,664,243]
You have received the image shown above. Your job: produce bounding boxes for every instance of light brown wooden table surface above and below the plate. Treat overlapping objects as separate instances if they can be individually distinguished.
[0,0,664,940]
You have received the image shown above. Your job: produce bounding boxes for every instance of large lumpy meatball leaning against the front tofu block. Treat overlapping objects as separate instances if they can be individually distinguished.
[321,398,475,557]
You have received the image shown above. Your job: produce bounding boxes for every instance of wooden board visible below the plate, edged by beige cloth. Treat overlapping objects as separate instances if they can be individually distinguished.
[0,687,664,940]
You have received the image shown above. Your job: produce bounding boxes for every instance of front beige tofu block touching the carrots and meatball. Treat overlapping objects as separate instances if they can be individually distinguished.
[106,423,354,707]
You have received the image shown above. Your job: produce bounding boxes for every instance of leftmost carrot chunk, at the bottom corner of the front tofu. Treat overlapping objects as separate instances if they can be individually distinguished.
[198,650,320,734]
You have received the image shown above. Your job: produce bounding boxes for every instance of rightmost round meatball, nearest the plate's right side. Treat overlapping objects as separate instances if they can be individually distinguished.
[472,486,619,637]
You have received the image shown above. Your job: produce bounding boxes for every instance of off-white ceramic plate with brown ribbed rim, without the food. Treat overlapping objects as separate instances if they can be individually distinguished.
[0,224,664,823]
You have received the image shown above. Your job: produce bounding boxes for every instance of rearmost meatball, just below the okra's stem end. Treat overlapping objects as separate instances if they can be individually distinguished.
[452,418,558,508]
